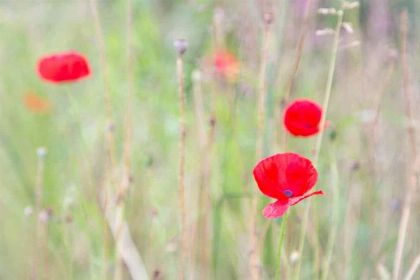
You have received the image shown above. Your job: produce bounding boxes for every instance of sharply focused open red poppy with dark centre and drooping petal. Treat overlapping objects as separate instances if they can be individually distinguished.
[254,153,324,219]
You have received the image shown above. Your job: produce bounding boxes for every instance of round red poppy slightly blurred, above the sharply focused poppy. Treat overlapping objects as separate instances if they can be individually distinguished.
[284,99,322,137]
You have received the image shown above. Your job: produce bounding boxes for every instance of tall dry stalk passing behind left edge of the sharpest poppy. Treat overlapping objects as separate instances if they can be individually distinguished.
[249,12,273,280]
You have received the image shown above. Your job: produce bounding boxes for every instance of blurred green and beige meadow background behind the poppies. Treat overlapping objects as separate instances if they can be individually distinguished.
[0,0,420,280]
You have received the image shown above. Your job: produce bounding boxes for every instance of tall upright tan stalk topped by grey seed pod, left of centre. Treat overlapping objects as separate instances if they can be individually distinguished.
[175,40,188,280]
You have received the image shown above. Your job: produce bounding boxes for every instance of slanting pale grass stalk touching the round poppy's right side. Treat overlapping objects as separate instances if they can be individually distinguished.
[295,10,344,279]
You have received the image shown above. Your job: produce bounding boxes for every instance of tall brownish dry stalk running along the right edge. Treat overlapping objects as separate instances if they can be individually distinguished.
[392,10,419,280]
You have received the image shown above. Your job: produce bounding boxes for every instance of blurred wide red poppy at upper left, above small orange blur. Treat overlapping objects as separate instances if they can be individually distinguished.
[38,52,90,83]
